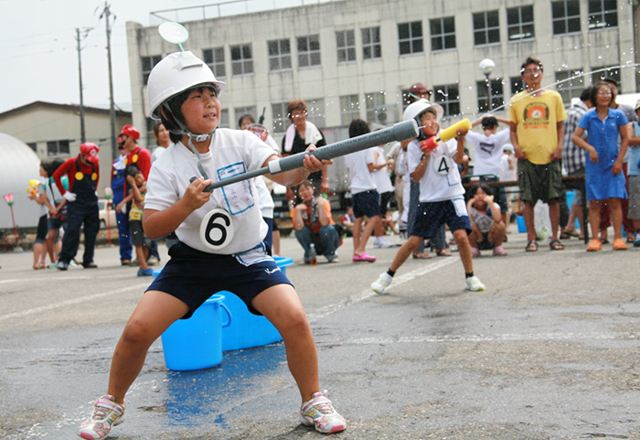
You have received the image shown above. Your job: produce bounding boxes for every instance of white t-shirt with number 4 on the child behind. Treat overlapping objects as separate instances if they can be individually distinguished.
[407,138,464,203]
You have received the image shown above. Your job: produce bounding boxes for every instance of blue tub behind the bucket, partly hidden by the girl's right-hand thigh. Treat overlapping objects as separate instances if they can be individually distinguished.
[221,257,293,351]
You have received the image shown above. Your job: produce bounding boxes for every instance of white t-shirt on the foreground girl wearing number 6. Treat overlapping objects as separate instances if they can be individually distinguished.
[145,128,274,255]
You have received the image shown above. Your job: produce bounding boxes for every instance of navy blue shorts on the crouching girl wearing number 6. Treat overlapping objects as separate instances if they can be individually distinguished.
[147,242,292,319]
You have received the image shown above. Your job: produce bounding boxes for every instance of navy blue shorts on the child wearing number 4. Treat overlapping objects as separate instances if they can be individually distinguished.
[411,197,471,238]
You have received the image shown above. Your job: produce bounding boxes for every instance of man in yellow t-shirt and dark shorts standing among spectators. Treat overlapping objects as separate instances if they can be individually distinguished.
[509,57,567,252]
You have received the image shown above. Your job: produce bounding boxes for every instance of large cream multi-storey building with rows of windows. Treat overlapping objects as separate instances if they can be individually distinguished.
[127,0,636,148]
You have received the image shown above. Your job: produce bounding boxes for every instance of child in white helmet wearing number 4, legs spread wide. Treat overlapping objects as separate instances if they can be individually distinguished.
[371,99,485,293]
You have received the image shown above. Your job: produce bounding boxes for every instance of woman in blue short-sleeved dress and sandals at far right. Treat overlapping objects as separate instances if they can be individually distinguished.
[572,82,629,251]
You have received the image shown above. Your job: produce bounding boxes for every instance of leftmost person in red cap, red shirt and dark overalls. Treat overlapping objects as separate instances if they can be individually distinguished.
[53,142,100,270]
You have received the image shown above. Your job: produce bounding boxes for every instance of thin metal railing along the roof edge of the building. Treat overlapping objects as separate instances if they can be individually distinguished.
[149,0,340,26]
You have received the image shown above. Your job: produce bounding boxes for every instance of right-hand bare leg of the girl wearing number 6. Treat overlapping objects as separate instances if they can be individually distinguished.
[252,284,320,402]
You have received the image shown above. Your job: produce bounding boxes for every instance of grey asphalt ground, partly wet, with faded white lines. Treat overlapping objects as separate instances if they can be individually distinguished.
[0,229,640,440]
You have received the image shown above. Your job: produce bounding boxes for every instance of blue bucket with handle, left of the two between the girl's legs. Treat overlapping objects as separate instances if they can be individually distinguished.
[162,295,233,371]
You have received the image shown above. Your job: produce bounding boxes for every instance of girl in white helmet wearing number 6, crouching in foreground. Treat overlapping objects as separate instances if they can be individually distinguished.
[79,52,346,440]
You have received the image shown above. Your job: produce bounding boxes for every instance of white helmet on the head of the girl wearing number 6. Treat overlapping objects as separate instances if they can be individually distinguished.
[147,51,226,120]
